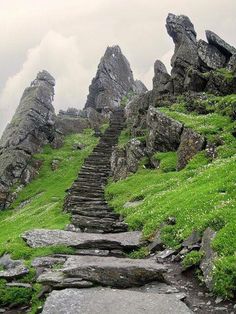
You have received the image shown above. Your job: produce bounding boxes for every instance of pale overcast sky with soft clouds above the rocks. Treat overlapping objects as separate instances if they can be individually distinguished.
[0,0,236,134]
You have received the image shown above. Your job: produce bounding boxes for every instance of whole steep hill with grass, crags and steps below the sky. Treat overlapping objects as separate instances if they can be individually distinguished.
[0,14,236,314]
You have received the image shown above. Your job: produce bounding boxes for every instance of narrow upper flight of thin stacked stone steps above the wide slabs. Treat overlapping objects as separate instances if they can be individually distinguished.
[65,110,127,233]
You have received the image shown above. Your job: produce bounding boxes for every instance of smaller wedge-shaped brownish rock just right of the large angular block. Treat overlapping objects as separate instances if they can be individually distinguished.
[177,128,206,170]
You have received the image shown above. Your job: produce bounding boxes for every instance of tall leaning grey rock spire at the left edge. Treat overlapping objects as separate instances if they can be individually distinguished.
[0,71,56,209]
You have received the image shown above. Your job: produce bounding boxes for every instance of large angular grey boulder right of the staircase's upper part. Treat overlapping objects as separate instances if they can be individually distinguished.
[147,107,183,153]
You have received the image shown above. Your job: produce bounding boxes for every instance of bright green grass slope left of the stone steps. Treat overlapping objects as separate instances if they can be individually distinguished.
[0,130,98,260]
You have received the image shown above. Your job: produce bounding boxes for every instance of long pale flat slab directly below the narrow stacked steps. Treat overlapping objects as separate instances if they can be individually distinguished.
[22,229,142,251]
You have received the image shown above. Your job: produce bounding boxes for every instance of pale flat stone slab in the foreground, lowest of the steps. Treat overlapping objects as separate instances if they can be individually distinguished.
[42,288,192,314]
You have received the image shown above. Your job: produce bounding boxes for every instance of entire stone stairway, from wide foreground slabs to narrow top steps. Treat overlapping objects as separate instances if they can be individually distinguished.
[23,110,191,314]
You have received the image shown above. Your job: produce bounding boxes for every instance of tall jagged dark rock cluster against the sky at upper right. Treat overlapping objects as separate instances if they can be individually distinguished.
[157,14,236,97]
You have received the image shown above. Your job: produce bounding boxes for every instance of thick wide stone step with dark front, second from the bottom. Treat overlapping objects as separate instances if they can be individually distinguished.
[37,255,167,288]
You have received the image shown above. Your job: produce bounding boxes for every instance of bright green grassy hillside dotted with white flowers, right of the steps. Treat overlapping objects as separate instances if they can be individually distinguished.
[107,98,236,298]
